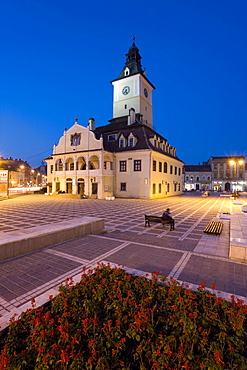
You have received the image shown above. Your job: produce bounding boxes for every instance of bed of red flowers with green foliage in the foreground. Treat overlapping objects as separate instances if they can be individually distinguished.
[0,266,247,370]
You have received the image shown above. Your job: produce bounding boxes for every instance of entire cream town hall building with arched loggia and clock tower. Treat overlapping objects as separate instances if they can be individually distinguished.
[46,42,183,199]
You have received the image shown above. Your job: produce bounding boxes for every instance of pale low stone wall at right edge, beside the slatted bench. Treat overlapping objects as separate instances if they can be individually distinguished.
[229,213,247,261]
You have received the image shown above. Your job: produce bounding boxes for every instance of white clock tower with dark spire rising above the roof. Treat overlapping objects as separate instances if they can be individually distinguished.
[111,38,155,128]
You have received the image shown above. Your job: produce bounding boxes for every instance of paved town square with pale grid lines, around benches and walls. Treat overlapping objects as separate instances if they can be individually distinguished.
[0,194,247,327]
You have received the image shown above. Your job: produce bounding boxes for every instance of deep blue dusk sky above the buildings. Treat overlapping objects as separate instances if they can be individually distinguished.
[0,0,247,167]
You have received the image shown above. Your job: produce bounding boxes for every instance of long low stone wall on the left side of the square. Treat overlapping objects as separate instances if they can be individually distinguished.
[0,217,105,261]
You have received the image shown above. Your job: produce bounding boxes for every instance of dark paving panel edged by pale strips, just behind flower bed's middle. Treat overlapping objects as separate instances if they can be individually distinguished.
[107,244,183,275]
